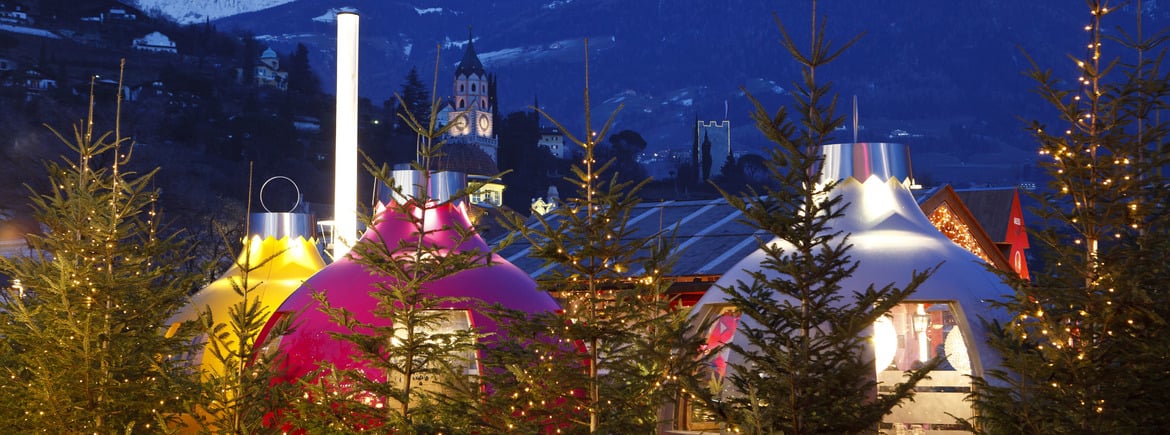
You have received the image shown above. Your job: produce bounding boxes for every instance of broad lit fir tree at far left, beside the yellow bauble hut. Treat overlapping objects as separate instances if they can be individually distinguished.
[0,72,197,433]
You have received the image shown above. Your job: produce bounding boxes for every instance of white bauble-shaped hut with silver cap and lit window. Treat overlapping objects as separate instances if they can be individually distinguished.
[691,143,1011,434]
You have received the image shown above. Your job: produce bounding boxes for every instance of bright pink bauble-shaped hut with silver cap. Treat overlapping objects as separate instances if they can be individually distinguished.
[255,171,559,380]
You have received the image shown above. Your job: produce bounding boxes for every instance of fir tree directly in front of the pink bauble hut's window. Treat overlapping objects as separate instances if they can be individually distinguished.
[293,47,491,434]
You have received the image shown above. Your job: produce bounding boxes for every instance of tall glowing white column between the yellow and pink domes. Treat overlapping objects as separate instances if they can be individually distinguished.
[333,12,358,261]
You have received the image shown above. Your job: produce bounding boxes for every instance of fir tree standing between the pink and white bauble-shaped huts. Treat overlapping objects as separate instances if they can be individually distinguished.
[477,41,700,434]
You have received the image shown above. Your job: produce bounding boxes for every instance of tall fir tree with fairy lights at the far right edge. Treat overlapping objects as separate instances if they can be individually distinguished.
[971,0,1170,434]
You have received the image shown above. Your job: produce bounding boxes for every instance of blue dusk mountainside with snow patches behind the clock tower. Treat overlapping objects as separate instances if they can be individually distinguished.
[139,0,1170,184]
